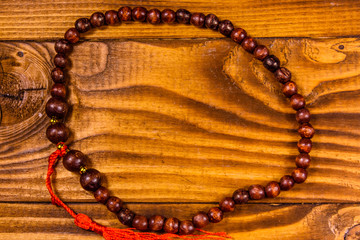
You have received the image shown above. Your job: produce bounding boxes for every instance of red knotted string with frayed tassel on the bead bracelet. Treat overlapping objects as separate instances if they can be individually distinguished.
[46,142,232,240]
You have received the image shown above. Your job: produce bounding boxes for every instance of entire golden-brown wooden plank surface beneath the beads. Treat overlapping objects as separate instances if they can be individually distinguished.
[0,0,360,240]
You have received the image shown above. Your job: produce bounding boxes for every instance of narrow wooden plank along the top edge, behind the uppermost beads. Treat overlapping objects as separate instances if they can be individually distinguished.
[0,0,360,41]
